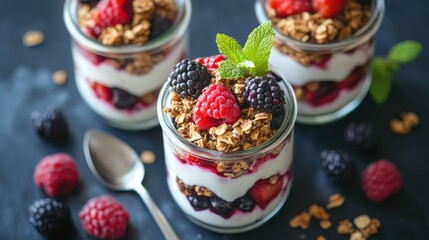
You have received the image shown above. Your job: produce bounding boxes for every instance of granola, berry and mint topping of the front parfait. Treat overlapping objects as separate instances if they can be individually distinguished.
[165,21,286,152]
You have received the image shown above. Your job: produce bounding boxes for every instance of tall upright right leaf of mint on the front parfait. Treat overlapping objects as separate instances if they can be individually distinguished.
[243,21,275,76]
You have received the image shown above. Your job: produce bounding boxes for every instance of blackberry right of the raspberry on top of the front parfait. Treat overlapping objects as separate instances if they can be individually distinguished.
[243,76,285,113]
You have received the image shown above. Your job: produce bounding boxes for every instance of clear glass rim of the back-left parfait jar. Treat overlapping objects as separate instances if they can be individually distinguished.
[63,0,192,54]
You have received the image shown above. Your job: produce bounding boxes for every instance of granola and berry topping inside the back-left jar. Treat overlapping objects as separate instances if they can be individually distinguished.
[77,0,177,45]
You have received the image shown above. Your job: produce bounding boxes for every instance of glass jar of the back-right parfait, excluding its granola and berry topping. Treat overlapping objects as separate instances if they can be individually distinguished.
[255,0,384,124]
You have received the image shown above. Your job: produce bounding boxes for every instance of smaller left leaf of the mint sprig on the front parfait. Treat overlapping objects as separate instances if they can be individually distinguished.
[216,33,243,64]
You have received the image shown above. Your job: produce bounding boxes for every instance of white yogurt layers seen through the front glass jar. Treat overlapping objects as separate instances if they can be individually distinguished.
[163,131,293,227]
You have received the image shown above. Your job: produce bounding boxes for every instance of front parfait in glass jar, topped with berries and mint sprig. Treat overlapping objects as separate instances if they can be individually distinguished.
[158,22,297,233]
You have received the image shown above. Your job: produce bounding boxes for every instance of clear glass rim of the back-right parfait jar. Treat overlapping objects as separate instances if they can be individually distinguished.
[255,0,385,52]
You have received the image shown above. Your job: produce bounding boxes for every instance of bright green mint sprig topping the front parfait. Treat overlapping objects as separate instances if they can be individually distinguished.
[216,21,275,79]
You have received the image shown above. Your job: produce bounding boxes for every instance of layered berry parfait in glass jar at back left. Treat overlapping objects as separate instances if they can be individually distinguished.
[64,0,191,129]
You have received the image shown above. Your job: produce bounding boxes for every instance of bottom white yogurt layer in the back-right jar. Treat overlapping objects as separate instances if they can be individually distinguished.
[297,78,370,115]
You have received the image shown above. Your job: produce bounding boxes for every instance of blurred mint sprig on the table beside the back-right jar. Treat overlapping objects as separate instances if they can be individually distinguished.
[369,40,422,105]
